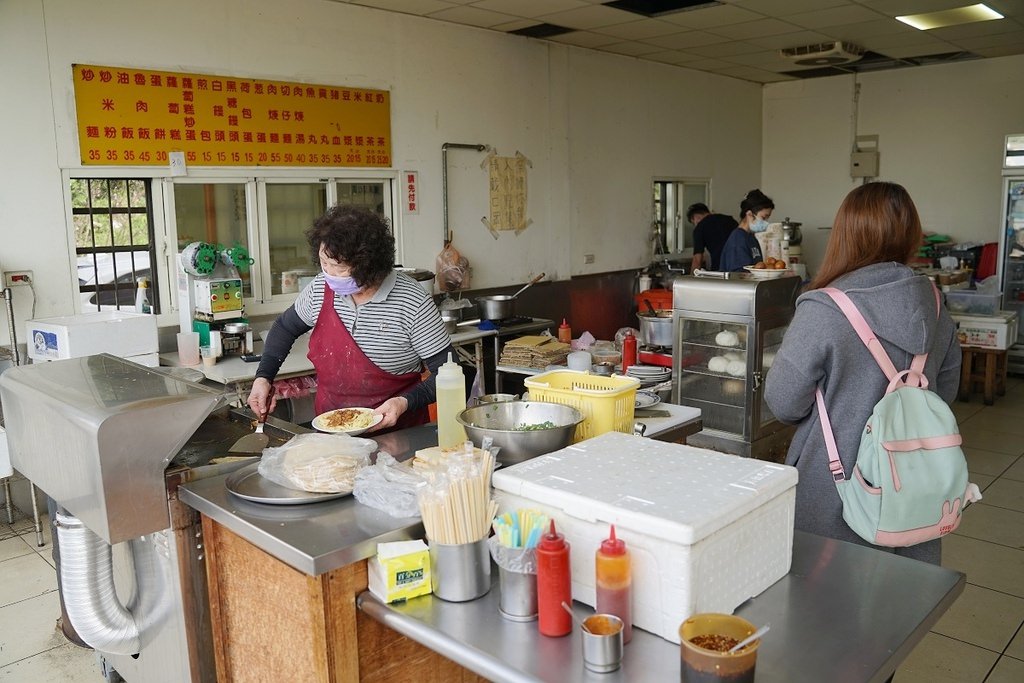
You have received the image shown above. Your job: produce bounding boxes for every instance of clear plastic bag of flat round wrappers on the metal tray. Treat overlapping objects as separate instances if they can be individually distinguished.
[259,433,377,494]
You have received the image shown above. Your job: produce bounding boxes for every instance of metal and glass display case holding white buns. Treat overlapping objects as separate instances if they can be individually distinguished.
[673,273,800,461]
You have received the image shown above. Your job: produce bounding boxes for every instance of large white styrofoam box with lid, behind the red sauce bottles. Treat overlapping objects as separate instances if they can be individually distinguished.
[494,432,797,643]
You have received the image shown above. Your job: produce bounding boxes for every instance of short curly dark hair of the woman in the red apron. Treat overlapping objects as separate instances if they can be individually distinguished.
[306,206,394,287]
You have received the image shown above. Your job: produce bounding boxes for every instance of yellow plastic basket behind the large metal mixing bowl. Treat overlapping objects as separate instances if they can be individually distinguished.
[523,370,640,443]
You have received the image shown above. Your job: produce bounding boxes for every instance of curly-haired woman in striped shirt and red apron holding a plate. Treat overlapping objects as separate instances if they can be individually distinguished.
[249,206,452,431]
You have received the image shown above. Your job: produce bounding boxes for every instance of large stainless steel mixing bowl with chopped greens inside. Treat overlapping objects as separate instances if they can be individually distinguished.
[456,400,583,465]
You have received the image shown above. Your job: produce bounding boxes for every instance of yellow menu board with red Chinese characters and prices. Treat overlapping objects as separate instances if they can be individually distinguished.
[73,65,391,167]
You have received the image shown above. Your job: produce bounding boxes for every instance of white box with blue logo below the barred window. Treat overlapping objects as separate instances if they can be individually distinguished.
[25,310,160,362]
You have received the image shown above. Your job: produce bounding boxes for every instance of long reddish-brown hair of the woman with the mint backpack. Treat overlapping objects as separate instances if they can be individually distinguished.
[810,182,923,289]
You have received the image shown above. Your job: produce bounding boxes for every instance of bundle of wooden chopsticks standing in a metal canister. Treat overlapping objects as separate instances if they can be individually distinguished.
[419,441,498,545]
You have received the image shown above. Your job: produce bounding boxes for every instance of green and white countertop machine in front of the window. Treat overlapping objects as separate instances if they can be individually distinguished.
[178,242,253,355]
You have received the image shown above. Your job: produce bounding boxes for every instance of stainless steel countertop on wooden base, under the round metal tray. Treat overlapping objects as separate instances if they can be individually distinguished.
[178,425,437,575]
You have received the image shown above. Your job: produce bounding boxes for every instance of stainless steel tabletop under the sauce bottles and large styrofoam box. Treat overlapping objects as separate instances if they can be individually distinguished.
[357,531,965,683]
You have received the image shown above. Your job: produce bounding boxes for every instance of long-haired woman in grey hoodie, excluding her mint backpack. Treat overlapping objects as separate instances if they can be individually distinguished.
[765,182,961,564]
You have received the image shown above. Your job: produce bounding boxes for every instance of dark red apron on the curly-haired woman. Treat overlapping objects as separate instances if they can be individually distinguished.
[307,283,430,431]
